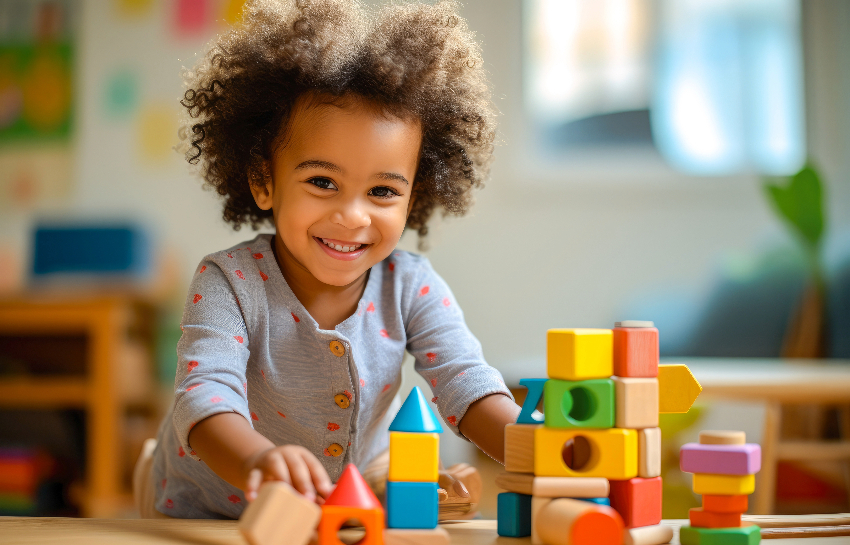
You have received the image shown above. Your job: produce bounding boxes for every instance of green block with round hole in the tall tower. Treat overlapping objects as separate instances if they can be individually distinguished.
[543,378,616,429]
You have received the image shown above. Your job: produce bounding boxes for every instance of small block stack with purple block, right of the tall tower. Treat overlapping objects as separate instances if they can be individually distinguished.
[679,431,761,545]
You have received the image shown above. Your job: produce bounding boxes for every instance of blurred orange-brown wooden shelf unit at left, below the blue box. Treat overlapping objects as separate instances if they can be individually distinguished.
[0,295,159,516]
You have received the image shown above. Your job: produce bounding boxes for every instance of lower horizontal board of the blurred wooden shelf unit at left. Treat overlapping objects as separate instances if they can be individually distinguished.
[0,377,89,409]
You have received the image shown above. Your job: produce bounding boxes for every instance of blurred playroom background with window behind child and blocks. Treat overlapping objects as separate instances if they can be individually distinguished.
[0,0,850,518]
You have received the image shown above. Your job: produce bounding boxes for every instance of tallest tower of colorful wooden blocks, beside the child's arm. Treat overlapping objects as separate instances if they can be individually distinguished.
[497,322,676,545]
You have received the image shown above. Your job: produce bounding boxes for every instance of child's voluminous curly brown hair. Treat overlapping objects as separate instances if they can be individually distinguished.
[180,0,495,242]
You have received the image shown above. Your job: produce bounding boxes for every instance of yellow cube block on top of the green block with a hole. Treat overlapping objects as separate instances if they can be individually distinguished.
[546,329,614,380]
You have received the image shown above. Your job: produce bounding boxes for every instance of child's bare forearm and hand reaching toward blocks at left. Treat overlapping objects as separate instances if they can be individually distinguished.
[189,413,333,501]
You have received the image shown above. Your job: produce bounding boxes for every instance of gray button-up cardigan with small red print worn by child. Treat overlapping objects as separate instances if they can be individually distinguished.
[152,235,510,518]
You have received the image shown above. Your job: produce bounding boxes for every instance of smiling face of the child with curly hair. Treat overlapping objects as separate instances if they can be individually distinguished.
[252,95,422,286]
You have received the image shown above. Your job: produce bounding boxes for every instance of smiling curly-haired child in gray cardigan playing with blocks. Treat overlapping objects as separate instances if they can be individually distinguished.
[148,0,519,518]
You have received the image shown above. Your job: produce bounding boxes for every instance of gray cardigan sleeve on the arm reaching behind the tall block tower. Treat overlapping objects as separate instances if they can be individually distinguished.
[405,258,513,437]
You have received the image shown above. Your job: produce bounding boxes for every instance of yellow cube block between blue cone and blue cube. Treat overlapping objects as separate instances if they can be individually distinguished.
[389,431,440,482]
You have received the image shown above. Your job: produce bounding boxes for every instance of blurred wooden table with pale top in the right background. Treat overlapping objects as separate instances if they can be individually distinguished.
[684,358,850,515]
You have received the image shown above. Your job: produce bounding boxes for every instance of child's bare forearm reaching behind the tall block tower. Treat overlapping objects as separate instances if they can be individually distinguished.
[458,394,520,464]
